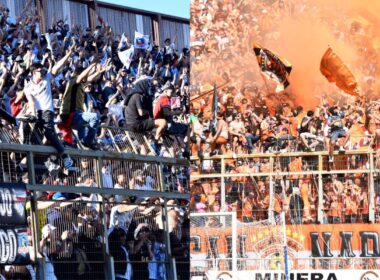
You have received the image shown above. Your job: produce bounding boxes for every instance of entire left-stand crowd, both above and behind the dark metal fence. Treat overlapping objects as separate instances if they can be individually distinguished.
[0,3,190,280]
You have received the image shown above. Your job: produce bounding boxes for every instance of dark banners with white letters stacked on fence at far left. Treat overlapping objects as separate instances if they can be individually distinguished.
[0,183,30,265]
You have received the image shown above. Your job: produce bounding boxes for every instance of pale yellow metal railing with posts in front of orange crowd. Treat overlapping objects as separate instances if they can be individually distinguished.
[190,150,380,223]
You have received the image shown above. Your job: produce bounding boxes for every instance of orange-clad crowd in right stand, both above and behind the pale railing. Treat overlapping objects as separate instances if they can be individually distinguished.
[190,0,380,224]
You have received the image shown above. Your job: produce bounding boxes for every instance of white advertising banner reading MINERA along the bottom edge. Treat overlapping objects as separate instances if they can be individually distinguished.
[206,270,380,280]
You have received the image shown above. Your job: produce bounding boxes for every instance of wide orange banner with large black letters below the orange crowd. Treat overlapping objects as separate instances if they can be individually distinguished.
[190,223,380,268]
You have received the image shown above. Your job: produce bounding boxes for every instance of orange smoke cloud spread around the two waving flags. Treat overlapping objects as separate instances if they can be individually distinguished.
[191,0,380,108]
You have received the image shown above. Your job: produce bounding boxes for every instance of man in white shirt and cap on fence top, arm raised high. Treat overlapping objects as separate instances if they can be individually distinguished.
[24,41,75,168]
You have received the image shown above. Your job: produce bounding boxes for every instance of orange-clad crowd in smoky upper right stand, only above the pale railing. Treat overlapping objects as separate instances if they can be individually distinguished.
[190,0,380,161]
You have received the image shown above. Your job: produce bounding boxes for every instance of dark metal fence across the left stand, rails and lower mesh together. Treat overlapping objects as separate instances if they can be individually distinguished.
[0,130,189,279]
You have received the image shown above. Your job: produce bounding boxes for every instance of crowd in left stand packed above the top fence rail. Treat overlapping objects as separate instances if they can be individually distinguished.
[0,8,190,165]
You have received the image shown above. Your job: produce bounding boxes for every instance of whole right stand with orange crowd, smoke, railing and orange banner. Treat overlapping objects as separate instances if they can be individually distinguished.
[190,0,380,279]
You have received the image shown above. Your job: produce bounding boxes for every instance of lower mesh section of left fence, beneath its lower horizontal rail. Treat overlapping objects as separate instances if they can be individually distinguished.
[30,200,189,279]
